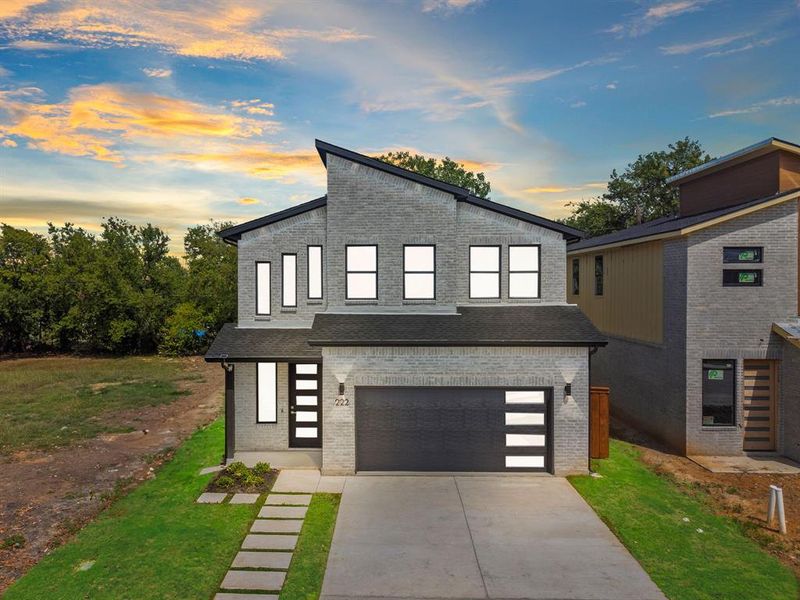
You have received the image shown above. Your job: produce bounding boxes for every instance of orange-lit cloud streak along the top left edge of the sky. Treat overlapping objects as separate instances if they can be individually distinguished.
[7,0,368,60]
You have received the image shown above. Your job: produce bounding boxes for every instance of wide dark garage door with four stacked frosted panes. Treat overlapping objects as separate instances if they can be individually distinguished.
[355,387,553,472]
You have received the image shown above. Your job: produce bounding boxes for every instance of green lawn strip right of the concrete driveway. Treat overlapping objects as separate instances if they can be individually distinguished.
[570,440,798,600]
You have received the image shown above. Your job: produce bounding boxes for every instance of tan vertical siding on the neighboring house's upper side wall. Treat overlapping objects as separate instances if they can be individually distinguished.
[567,241,664,344]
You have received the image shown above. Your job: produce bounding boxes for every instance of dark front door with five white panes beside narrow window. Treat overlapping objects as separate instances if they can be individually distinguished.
[289,363,322,448]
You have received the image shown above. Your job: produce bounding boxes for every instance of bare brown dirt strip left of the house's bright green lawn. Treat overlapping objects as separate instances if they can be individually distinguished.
[0,357,223,595]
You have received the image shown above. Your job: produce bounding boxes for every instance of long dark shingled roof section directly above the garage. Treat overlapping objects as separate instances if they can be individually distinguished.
[308,304,606,346]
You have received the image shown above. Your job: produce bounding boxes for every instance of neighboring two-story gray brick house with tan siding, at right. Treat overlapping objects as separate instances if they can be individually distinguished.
[567,138,800,460]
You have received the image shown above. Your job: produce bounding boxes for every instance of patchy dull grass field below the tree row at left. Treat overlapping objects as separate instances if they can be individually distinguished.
[0,356,199,454]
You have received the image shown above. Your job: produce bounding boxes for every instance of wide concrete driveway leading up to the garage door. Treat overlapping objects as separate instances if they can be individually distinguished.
[322,476,664,600]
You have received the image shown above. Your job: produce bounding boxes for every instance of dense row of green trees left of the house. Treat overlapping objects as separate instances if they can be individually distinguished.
[0,217,236,354]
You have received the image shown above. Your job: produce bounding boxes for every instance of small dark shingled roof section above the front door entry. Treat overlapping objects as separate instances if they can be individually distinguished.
[205,323,322,362]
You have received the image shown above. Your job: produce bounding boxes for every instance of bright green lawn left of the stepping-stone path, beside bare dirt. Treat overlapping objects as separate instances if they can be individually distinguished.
[4,419,255,600]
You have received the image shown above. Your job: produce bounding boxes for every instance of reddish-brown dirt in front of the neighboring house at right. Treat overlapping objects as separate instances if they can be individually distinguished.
[612,422,800,577]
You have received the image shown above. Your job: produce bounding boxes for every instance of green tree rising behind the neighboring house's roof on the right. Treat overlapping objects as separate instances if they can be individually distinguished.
[563,137,711,236]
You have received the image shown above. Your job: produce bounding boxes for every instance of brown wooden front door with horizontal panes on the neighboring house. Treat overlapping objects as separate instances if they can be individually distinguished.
[742,360,778,452]
